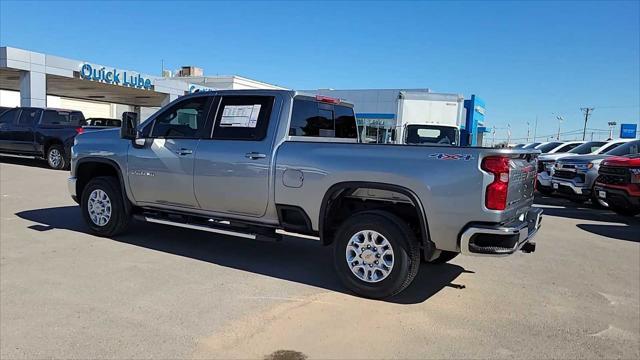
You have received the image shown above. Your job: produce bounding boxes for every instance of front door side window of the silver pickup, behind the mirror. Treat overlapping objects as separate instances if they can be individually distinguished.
[151,96,211,139]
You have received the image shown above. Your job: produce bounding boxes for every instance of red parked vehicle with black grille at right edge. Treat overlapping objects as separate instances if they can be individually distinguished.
[594,154,640,215]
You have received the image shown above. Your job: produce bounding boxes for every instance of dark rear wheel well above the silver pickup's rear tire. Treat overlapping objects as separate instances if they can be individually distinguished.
[319,183,435,252]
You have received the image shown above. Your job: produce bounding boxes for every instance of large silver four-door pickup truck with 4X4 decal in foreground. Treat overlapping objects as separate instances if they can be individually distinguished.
[69,90,541,298]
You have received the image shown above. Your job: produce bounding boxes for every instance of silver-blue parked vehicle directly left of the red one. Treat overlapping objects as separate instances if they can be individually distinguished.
[551,140,640,205]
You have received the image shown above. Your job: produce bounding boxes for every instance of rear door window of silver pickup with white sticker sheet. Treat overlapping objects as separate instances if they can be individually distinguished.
[211,95,274,141]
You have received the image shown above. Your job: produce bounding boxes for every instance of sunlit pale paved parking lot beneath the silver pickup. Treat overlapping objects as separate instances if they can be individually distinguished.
[0,158,640,359]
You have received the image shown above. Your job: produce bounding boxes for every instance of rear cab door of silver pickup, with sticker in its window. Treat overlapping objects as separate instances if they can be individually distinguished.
[194,95,281,217]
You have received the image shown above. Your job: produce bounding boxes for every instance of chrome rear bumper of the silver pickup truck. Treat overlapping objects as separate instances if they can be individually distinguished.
[460,208,542,256]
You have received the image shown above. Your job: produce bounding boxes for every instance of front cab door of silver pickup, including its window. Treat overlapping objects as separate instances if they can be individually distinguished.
[127,96,212,208]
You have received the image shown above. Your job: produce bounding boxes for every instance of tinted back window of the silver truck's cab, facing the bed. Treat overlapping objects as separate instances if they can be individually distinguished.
[289,100,358,139]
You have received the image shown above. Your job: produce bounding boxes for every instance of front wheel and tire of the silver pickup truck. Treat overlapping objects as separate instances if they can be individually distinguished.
[80,176,131,237]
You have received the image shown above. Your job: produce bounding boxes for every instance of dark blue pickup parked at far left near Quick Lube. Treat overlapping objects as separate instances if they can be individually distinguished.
[0,107,84,169]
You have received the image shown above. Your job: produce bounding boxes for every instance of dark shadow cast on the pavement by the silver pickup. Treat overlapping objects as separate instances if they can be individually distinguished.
[16,206,470,304]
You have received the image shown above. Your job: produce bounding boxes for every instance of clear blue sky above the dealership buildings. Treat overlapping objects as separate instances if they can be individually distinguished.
[0,0,640,142]
